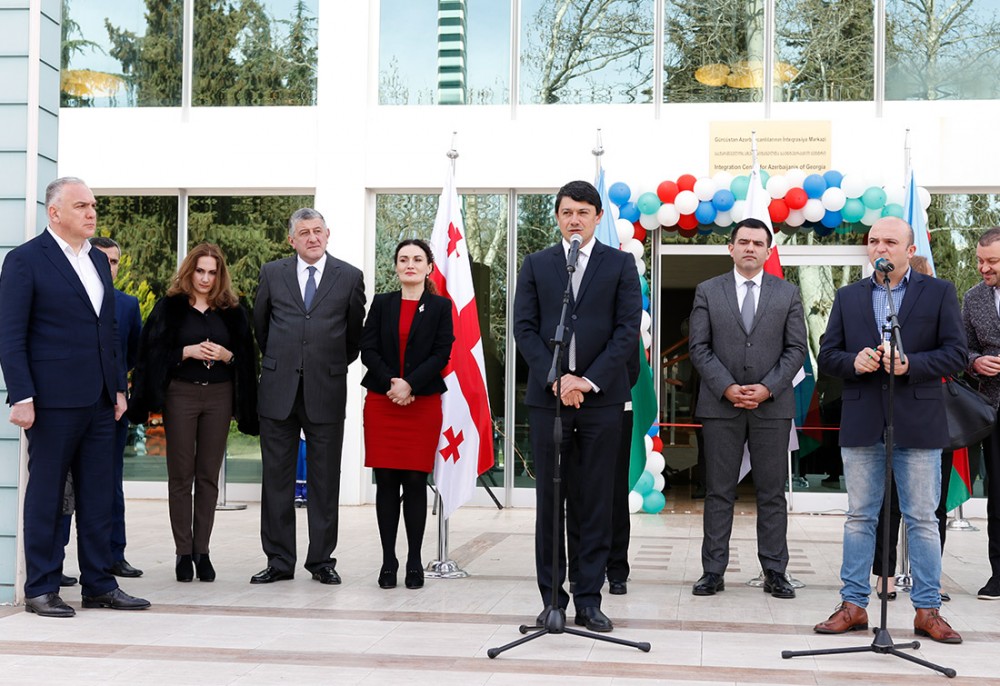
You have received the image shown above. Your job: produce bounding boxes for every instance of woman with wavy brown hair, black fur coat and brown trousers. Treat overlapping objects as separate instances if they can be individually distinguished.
[129,243,258,581]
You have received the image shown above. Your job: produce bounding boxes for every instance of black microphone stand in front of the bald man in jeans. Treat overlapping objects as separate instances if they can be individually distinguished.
[781,272,957,679]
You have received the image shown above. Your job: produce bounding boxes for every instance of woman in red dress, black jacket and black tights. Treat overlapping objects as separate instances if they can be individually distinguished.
[361,239,455,588]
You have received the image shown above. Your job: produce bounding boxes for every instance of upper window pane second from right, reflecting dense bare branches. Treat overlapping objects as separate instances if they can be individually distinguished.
[774,0,874,102]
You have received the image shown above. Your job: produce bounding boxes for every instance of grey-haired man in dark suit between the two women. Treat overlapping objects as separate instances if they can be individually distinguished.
[250,208,365,584]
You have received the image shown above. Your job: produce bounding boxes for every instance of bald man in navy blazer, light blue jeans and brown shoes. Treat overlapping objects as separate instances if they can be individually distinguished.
[814,217,966,643]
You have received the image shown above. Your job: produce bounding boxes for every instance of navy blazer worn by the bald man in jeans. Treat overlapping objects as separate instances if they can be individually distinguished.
[819,269,966,448]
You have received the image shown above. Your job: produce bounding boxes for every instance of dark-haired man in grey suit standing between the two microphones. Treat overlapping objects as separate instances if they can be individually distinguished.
[689,219,806,598]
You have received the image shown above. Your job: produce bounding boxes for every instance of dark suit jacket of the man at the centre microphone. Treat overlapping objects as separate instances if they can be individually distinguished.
[514,238,642,408]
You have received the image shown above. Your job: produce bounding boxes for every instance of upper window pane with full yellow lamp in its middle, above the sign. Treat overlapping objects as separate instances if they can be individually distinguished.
[663,0,760,102]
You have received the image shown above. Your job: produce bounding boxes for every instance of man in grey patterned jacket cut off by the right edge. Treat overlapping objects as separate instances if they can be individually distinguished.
[962,226,1000,600]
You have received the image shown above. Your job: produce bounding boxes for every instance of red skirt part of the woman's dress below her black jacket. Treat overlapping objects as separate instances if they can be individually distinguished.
[364,391,441,473]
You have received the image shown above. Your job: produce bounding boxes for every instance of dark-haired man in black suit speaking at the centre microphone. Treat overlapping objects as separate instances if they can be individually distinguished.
[514,181,642,631]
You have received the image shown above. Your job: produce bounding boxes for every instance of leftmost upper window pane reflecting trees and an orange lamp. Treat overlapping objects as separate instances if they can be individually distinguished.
[60,0,183,107]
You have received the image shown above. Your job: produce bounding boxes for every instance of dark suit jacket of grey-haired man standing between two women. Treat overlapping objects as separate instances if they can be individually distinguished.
[253,253,365,423]
